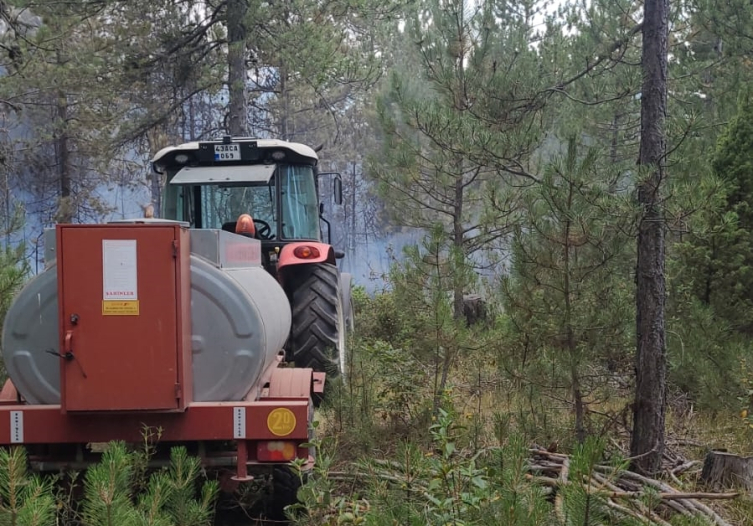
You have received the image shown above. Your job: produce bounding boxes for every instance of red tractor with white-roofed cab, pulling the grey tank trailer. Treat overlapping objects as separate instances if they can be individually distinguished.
[152,136,354,388]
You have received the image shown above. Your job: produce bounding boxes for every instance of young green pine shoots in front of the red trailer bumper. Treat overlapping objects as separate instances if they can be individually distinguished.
[0,442,219,526]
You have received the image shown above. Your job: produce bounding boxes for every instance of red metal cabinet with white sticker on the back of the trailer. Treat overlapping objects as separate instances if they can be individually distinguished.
[57,223,192,412]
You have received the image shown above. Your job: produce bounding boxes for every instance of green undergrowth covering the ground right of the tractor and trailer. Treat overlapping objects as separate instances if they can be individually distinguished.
[282,291,753,526]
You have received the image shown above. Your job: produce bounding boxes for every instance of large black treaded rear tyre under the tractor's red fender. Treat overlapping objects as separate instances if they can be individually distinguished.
[291,263,346,384]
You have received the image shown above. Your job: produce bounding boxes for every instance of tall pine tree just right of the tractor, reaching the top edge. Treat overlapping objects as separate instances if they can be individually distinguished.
[369,1,547,318]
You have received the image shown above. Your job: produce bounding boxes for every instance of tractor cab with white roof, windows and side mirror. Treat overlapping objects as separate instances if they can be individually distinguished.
[153,137,342,273]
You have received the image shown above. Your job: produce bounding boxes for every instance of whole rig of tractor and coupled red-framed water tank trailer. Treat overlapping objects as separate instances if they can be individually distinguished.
[0,137,353,520]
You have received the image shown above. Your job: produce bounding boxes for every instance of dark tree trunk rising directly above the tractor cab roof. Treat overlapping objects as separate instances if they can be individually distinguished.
[227,0,248,136]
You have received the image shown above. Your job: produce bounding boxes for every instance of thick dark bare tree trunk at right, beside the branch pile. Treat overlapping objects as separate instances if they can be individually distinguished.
[630,0,669,475]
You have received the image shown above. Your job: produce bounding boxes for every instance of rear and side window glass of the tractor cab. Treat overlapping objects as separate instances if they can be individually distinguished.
[165,165,320,240]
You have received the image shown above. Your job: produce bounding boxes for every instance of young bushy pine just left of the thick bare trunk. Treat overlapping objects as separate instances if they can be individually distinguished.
[503,137,632,442]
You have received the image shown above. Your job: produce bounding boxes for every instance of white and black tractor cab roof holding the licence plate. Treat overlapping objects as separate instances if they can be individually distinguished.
[152,136,319,168]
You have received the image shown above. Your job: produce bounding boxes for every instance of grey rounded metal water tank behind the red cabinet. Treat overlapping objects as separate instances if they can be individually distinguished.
[2,229,292,404]
